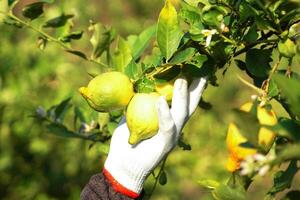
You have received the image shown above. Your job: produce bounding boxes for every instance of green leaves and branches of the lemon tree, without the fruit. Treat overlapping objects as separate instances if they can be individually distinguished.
[0,0,300,199]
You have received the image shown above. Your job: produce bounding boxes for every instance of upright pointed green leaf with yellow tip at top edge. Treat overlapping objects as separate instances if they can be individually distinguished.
[157,0,182,61]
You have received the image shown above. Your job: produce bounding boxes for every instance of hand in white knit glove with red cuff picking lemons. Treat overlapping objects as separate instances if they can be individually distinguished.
[103,77,207,198]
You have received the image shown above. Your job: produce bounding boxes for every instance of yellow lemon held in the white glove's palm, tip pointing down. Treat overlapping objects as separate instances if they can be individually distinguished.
[126,92,159,145]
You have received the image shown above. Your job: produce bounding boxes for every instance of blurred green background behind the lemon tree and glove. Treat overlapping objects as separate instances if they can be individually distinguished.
[0,0,300,200]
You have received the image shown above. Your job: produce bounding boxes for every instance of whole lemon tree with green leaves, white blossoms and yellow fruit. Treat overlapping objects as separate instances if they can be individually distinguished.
[0,0,300,199]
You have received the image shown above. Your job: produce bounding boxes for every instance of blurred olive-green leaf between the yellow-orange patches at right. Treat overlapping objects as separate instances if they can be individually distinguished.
[233,109,260,146]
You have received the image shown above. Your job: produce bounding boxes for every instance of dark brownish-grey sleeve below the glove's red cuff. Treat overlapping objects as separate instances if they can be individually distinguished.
[80,173,143,200]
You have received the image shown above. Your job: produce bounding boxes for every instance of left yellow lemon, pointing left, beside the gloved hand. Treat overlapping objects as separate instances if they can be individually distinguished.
[79,72,134,112]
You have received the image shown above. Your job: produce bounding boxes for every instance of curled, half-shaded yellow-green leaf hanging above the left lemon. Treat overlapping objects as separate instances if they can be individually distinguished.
[89,23,116,59]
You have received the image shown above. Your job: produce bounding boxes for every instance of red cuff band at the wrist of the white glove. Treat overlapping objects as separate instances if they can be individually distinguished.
[102,167,139,199]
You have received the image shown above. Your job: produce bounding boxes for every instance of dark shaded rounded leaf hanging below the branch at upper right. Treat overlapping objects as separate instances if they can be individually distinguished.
[246,49,272,78]
